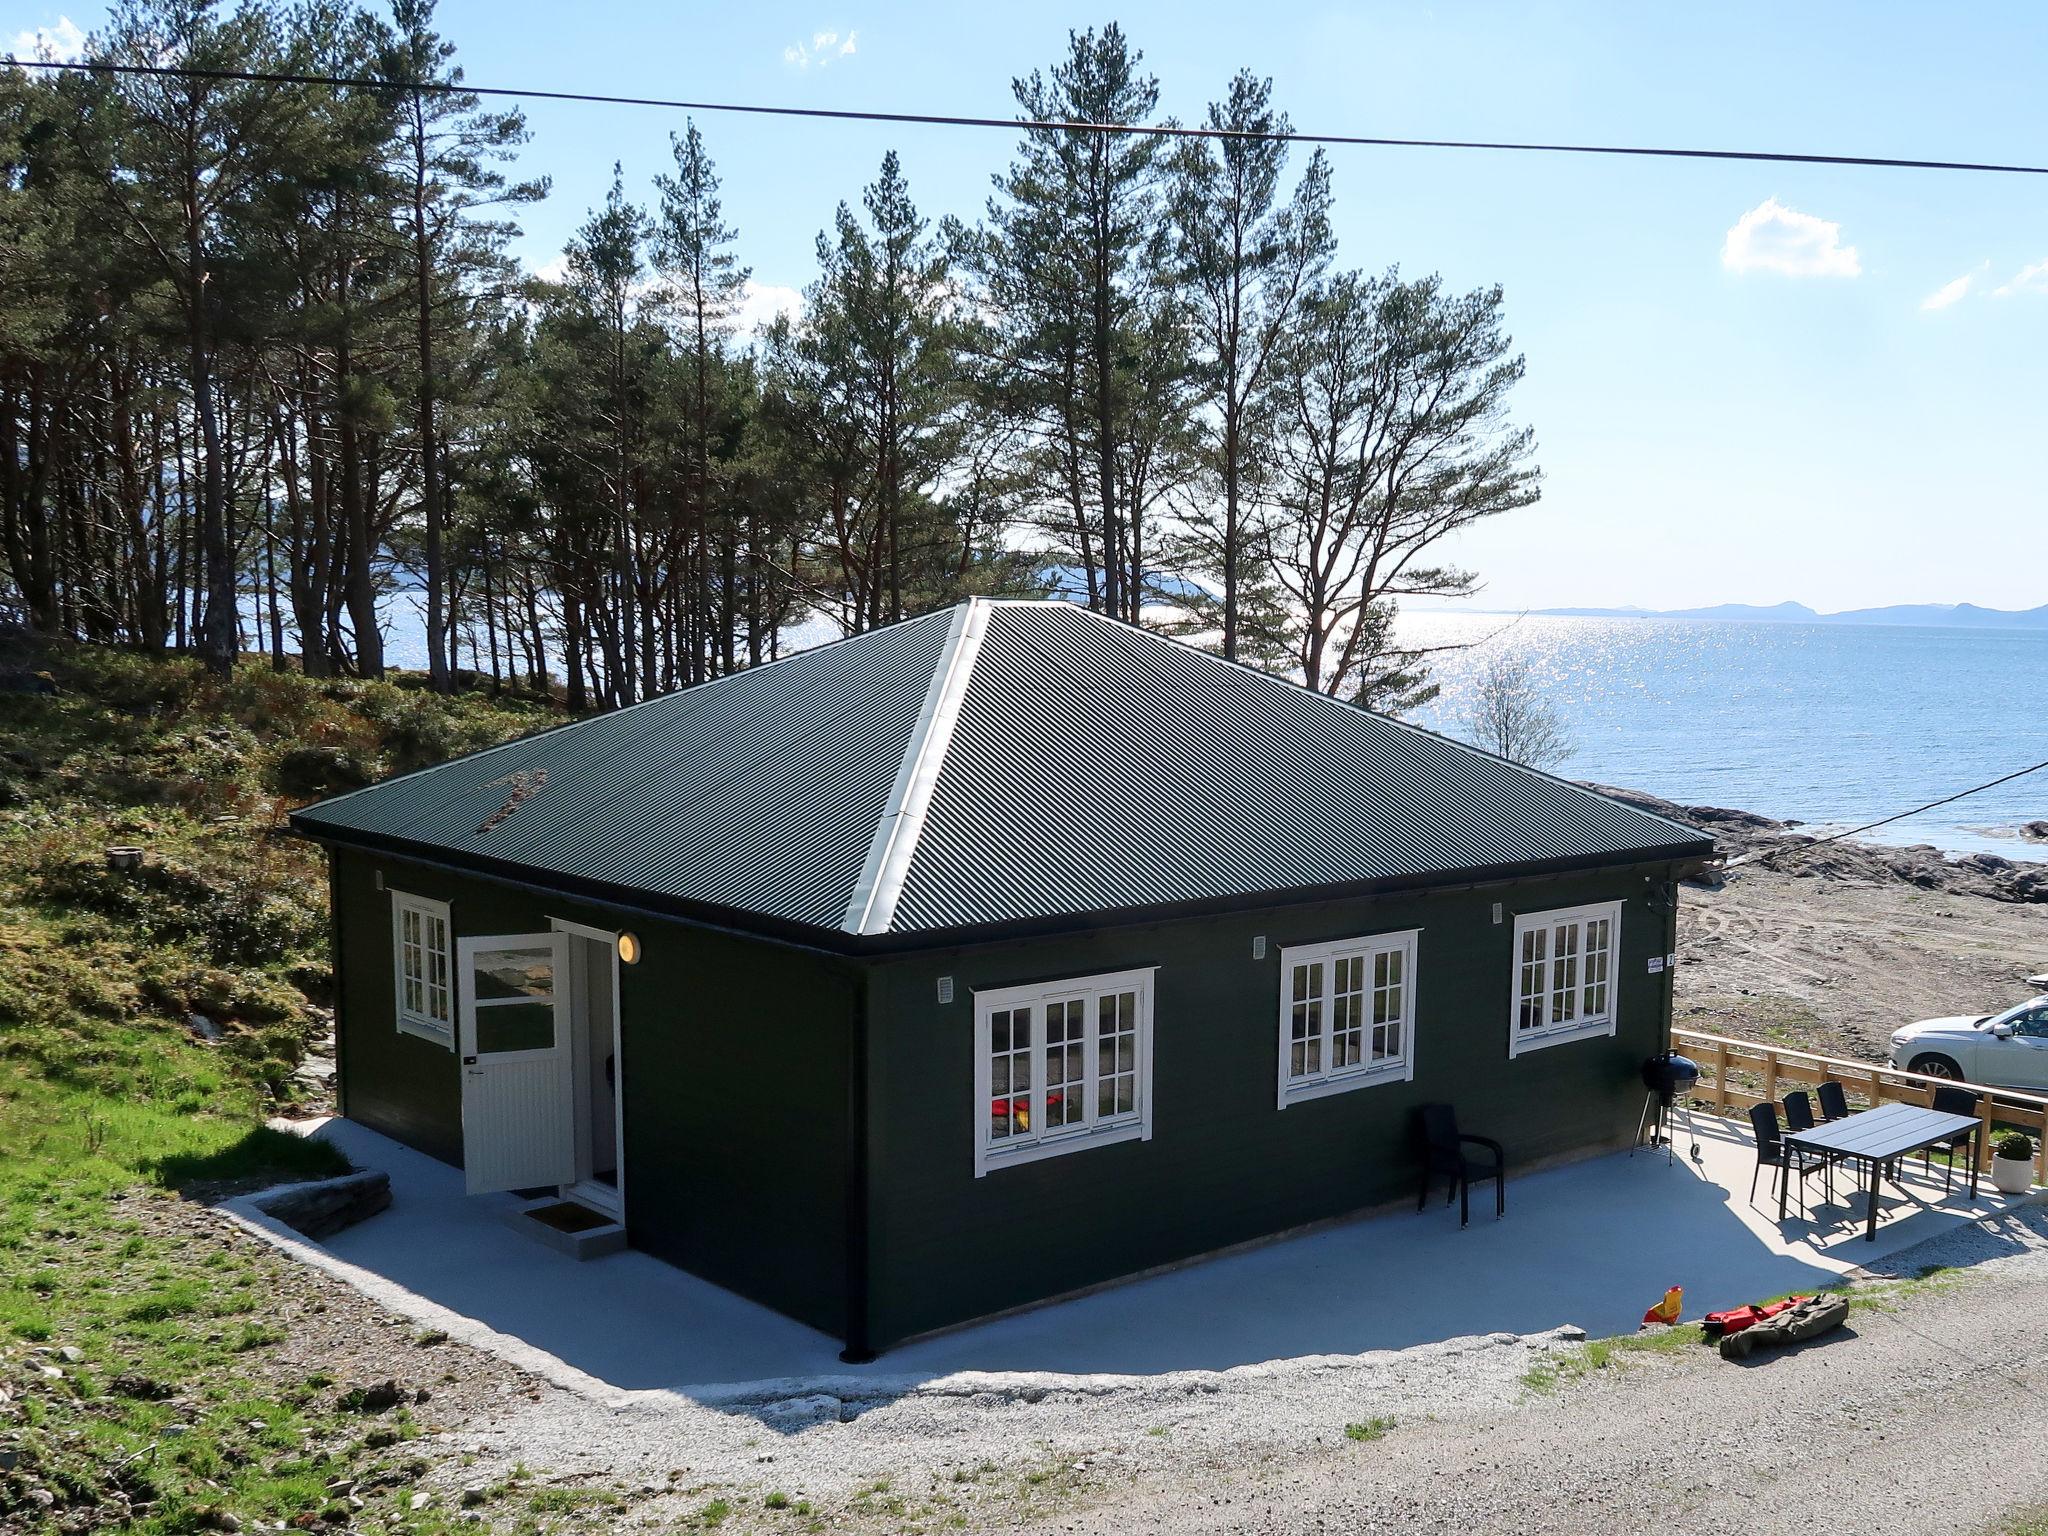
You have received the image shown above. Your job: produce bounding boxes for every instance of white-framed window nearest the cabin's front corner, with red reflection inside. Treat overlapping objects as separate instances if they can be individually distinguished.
[975,969,1153,1178]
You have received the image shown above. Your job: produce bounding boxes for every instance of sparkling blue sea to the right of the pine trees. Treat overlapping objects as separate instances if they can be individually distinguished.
[1397,612,2048,860]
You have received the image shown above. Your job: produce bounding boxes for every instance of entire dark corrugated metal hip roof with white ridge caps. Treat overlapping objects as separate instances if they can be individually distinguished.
[295,602,1710,936]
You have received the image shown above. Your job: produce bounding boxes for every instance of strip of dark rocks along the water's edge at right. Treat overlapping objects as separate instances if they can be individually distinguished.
[1587,784,2048,903]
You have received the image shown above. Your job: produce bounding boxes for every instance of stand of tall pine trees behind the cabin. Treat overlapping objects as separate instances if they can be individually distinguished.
[0,0,1538,709]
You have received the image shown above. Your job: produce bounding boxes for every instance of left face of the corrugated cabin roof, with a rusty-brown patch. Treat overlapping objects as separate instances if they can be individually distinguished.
[293,612,952,928]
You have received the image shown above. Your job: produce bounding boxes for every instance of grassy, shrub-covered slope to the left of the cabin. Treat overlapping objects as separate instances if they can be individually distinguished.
[0,639,547,1536]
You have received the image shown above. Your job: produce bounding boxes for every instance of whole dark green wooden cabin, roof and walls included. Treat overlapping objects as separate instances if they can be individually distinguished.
[293,600,1712,1358]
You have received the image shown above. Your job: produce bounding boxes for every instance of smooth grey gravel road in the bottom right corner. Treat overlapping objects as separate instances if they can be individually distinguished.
[1065,1206,2048,1536]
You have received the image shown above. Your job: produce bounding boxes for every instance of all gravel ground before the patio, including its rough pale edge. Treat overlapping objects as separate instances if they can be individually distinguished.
[368,1206,2048,1536]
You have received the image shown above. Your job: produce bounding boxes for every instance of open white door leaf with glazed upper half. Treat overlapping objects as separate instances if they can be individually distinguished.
[457,934,575,1194]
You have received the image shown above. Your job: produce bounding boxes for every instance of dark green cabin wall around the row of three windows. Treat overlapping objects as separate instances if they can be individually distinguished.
[868,872,1675,1343]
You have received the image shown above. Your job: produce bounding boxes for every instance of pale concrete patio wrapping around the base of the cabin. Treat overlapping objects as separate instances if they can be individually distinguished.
[236,1114,2011,1395]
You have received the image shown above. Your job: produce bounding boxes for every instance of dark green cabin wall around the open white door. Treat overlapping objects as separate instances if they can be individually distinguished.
[334,850,860,1335]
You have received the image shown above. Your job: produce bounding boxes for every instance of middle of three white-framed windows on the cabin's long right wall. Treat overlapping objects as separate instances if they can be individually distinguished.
[1280,928,1421,1110]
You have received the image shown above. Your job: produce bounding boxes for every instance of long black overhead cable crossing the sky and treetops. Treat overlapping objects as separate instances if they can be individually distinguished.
[6,57,2048,176]
